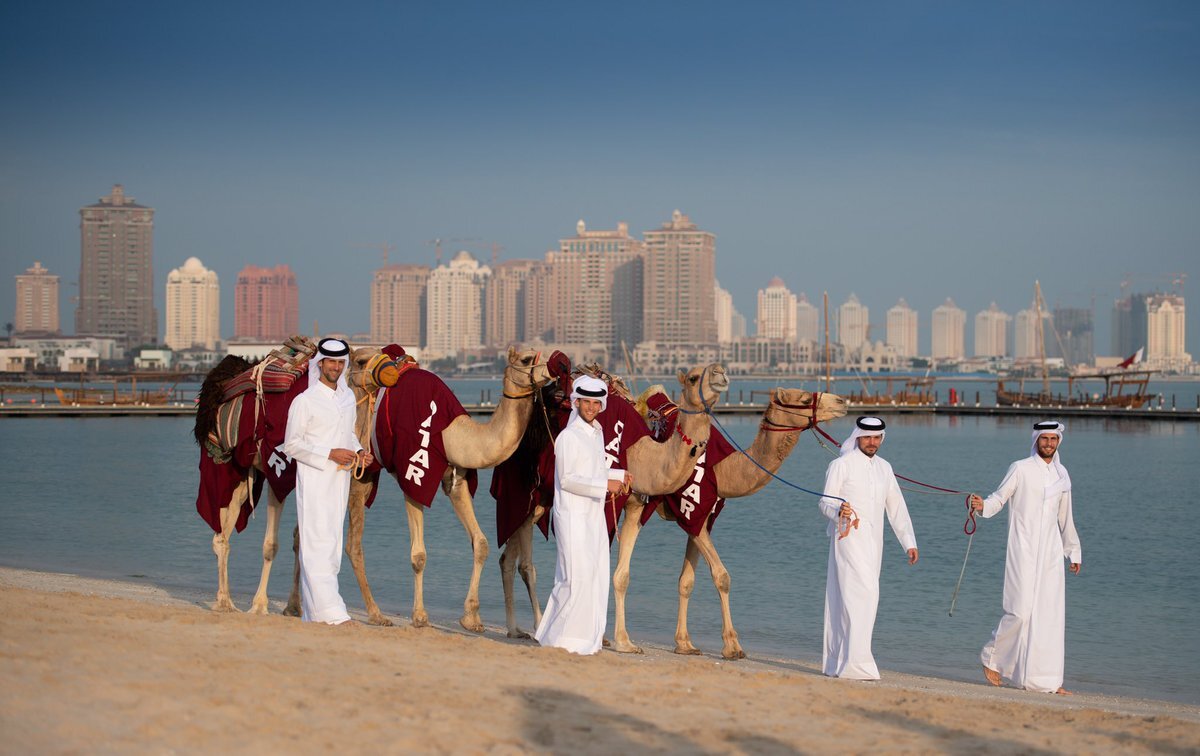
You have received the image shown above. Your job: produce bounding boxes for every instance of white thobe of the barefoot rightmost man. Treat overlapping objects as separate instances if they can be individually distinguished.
[979,456,1082,692]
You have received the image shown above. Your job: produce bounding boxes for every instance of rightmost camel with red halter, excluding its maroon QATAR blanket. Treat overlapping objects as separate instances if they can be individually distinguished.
[613,389,846,659]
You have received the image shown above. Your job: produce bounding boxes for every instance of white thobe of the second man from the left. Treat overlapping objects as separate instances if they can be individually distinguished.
[534,416,625,654]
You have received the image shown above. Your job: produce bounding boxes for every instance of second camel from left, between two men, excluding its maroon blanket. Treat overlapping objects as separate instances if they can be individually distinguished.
[346,349,551,632]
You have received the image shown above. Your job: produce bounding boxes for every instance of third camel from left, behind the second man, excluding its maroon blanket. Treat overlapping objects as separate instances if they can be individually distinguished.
[500,362,730,641]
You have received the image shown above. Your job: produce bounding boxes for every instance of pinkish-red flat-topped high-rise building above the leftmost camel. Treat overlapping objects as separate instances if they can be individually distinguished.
[233,264,300,342]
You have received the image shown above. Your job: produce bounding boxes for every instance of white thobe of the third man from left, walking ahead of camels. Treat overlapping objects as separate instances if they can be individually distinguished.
[820,449,917,680]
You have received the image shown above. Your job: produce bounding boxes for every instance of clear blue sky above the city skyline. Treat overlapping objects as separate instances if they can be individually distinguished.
[0,1,1200,358]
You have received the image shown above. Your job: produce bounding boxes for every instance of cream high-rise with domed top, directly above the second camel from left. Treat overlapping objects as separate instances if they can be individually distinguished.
[425,250,492,360]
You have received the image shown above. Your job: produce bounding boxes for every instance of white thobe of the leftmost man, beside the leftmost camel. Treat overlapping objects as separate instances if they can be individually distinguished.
[283,382,362,624]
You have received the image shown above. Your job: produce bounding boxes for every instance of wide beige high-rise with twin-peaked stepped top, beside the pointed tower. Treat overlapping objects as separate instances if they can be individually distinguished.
[546,221,643,349]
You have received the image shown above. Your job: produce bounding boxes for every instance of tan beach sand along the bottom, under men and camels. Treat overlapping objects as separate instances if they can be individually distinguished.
[0,569,1200,754]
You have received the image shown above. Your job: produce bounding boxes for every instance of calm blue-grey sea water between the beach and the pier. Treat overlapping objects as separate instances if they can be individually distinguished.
[0,405,1200,703]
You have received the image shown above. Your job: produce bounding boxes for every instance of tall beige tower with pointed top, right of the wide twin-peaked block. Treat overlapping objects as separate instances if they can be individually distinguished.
[642,210,716,346]
